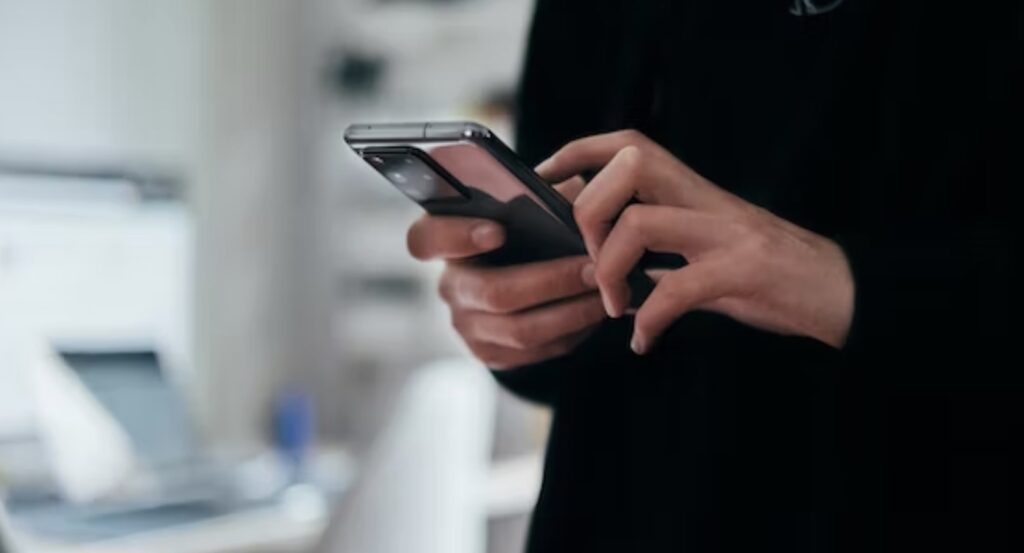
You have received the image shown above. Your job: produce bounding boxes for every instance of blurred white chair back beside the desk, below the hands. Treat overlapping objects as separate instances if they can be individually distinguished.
[323,359,495,553]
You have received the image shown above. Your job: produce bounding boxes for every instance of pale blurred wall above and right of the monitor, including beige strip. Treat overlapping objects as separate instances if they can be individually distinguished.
[0,0,300,442]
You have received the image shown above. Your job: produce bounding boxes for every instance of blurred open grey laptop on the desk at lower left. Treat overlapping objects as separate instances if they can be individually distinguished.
[8,348,271,542]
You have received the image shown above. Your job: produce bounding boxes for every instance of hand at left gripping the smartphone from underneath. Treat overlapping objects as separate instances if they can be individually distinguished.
[408,179,605,369]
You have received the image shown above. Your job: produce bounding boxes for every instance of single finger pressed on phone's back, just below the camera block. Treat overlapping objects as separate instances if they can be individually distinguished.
[406,215,505,260]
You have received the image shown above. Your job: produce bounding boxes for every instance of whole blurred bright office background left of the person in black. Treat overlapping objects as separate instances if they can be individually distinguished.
[0,0,547,553]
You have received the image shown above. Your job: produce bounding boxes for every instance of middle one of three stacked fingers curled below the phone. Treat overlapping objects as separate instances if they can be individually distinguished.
[453,294,605,349]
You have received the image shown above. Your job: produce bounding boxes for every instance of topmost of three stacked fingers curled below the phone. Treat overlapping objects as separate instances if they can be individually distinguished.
[440,256,597,313]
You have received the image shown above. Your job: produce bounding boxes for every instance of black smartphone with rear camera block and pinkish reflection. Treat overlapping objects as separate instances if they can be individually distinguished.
[345,122,654,306]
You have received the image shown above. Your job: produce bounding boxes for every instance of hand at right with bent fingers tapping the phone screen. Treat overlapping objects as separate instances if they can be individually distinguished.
[538,131,854,353]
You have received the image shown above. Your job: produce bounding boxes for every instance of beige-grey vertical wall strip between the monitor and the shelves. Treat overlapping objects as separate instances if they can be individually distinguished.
[193,0,303,442]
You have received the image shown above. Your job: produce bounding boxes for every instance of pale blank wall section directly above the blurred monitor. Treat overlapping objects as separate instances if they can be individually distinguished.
[0,0,205,166]
